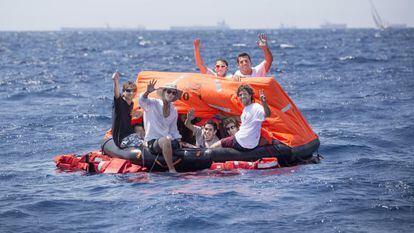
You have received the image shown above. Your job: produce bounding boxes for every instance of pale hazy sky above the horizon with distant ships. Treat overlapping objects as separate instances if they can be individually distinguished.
[0,0,414,31]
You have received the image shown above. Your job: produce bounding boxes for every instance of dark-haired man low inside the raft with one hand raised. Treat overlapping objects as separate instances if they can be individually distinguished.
[185,108,219,148]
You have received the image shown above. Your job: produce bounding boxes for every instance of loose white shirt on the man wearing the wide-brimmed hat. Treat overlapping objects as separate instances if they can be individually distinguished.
[139,94,181,141]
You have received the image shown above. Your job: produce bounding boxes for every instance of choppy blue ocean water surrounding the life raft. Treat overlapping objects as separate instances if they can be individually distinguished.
[0,29,414,233]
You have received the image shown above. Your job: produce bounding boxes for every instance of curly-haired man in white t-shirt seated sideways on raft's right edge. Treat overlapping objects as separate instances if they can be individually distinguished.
[210,84,270,151]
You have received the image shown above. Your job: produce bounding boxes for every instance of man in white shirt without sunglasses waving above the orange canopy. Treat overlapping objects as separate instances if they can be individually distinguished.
[234,33,273,78]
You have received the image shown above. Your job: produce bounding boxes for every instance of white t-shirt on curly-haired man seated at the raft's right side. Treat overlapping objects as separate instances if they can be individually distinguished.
[234,103,266,149]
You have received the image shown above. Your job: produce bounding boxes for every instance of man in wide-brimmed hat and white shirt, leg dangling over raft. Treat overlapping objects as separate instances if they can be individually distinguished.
[139,80,182,173]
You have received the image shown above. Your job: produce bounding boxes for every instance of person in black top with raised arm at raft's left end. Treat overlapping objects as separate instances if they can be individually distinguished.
[112,71,143,149]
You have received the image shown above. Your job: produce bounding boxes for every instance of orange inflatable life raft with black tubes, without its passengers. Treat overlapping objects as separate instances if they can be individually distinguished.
[56,71,319,173]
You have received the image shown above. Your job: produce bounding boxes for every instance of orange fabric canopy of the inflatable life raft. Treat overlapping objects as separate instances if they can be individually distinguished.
[134,71,319,148]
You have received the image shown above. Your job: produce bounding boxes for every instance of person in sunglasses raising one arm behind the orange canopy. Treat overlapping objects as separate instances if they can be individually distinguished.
[194,38,233,78]
